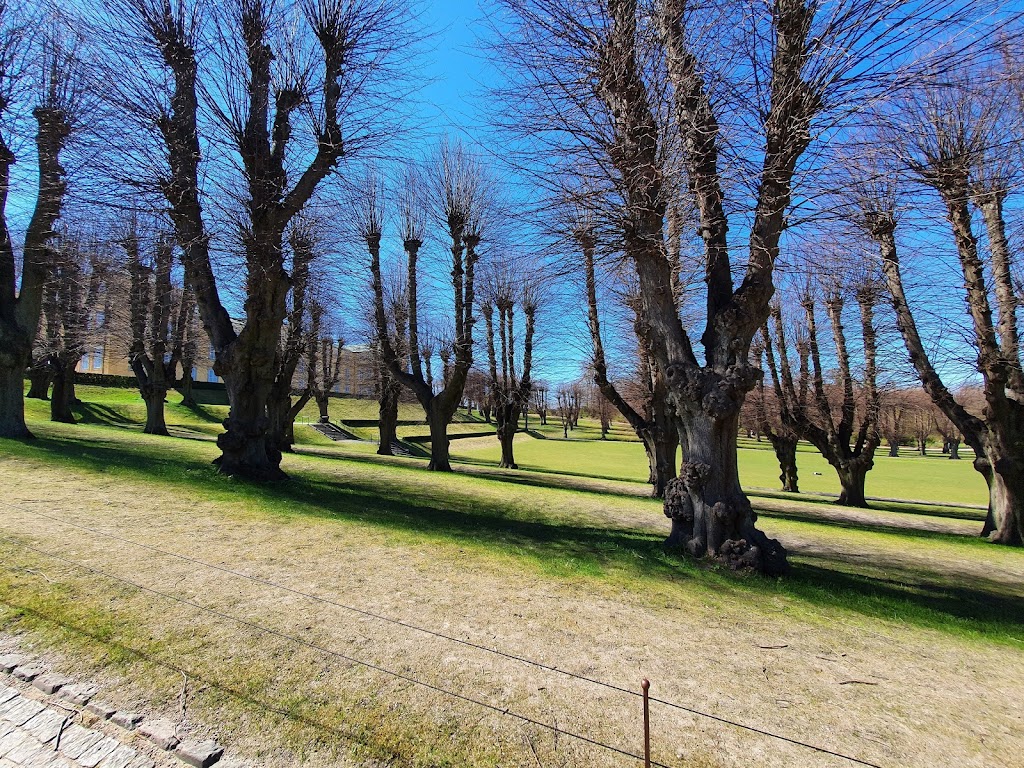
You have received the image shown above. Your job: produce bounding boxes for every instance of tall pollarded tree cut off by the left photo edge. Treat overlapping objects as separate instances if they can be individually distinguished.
[0,12,81,437]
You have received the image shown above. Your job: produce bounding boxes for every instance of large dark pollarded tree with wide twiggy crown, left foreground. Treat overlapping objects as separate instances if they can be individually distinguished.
[101,0,413,479]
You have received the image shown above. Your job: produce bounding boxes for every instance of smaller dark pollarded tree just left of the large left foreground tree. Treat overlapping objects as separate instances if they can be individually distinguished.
[121,221,196,435]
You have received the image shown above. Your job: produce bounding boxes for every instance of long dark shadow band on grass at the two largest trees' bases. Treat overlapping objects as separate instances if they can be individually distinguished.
[9,437,1024,645]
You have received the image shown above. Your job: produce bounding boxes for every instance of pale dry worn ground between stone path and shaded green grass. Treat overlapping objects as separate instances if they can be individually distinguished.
[0,459,1024,768]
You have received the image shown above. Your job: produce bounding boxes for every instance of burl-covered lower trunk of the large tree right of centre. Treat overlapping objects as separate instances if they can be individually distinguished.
[665,411,788,574]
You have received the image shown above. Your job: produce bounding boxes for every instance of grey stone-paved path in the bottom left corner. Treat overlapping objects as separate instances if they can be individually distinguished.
[0,684,157,768]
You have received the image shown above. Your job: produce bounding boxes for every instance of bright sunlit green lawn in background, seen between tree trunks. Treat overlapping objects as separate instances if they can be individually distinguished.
[26,386,987,506]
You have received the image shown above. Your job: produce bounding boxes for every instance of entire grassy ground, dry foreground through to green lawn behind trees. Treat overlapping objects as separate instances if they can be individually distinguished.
[0,387,1024,768]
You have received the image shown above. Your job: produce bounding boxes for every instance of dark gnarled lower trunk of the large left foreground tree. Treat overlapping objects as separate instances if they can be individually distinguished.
[215,368,288,480]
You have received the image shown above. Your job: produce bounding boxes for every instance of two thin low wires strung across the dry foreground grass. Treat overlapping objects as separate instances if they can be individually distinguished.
[0,502,883,768]
